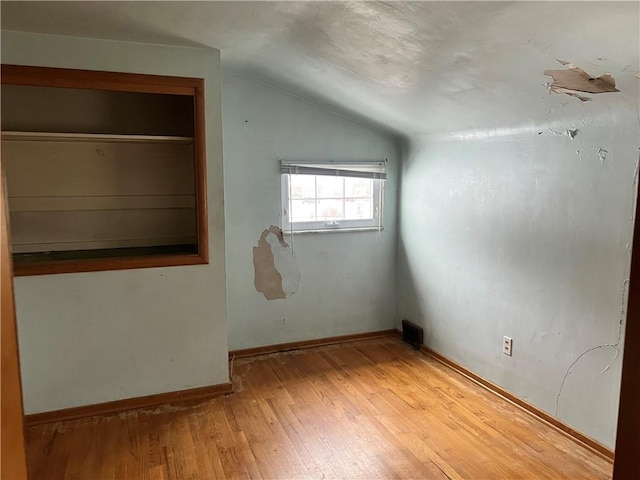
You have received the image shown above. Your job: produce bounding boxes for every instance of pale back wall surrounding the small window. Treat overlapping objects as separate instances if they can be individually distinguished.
[223,75,398,350]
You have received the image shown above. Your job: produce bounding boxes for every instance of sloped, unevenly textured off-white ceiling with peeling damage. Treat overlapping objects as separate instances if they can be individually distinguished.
[1,1,640,136]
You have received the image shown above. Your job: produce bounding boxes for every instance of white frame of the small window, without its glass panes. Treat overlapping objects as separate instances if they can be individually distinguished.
[280,161,386,234]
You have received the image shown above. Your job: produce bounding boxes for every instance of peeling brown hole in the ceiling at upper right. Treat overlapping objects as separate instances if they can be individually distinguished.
[544,60,620,102]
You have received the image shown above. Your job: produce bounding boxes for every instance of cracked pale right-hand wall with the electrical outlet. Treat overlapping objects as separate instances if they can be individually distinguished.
[398,73,640,447]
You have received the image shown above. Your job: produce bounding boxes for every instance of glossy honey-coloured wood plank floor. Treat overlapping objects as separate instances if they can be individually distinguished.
[27,338,612,480]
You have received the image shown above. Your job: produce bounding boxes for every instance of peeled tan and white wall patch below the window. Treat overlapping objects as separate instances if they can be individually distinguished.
[253,225,300,300]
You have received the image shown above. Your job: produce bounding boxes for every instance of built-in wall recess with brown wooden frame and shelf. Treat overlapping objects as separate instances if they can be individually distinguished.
[2,65,208,275]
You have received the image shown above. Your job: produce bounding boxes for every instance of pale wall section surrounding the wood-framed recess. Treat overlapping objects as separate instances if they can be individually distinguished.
[2,31,228,413]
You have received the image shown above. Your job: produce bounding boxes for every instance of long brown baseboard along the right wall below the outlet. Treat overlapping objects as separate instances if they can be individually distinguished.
[420,345,614,463]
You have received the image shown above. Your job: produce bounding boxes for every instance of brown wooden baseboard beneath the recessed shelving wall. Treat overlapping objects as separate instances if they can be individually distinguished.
[24,383,233,427]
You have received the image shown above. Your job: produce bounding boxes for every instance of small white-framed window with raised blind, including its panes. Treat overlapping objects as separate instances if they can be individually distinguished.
[280,161,386,232]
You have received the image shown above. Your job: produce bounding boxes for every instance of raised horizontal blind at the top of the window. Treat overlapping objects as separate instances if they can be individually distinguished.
[280,160,387,180]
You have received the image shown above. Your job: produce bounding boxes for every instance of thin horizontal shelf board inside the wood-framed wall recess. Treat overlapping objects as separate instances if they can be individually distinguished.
[2,131,193,144]
